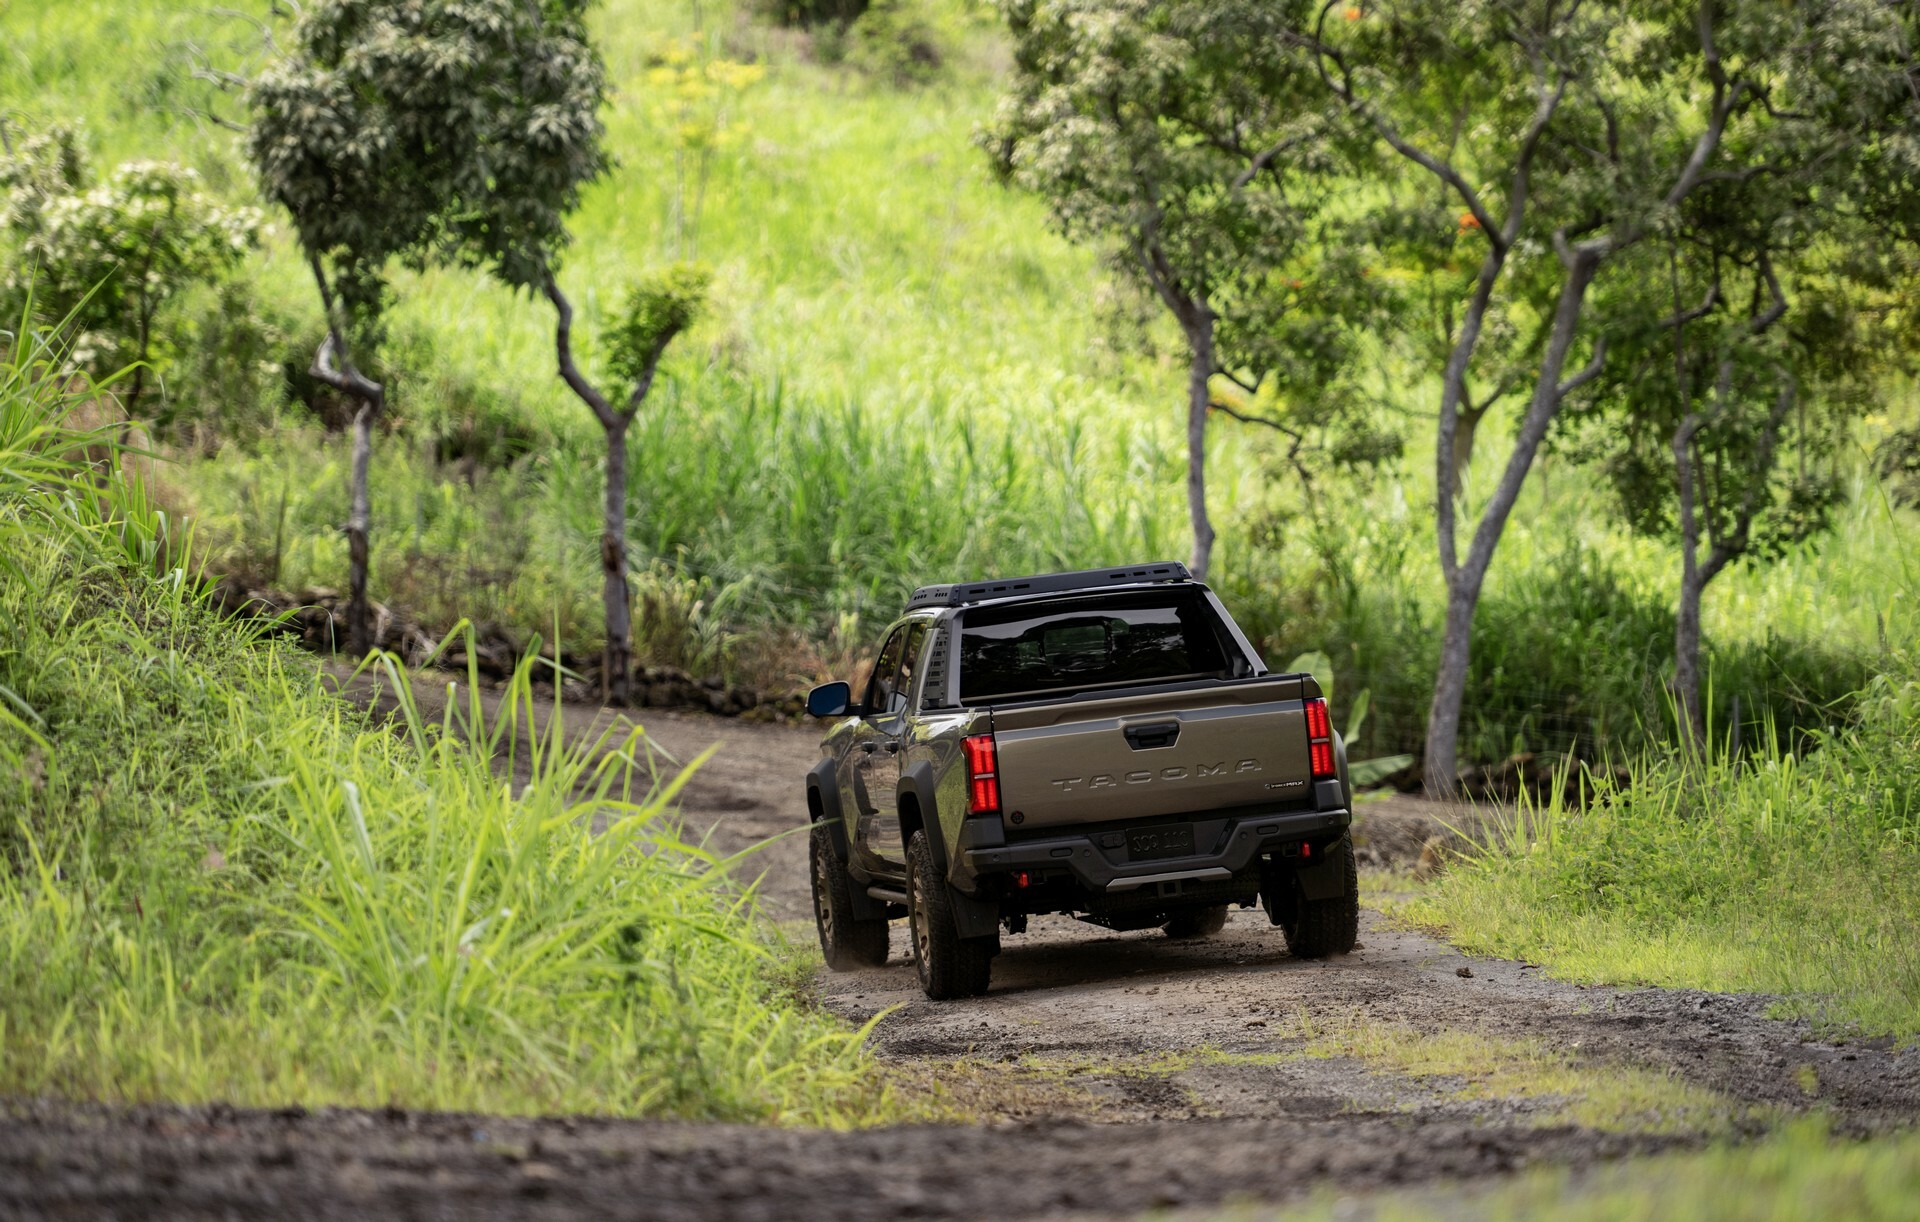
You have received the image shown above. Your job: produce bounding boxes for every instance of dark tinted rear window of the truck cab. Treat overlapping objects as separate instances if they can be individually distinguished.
[960,590,1246,705]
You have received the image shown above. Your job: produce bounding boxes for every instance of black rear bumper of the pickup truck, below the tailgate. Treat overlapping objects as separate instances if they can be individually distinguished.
[960,809,1354,893]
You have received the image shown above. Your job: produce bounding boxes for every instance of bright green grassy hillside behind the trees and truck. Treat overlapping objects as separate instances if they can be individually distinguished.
[11,0,1912,763]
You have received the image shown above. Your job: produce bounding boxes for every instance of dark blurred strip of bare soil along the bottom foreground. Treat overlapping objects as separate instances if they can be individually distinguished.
[0,1105,1690,1222]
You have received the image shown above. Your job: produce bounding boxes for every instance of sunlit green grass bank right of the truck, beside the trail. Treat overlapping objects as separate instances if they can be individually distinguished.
[1396,651,1920,1039]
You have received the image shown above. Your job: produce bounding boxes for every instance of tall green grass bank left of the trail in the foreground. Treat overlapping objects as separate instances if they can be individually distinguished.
[0,336,889,1124]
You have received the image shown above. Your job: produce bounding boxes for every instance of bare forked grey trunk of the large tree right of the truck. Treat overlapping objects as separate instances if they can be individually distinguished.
[1423,250,1605,797]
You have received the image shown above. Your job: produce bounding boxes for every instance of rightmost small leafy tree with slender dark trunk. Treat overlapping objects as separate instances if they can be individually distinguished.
[1586,137,1914,753]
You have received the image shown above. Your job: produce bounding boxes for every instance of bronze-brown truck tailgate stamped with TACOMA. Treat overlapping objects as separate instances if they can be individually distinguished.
[993,674,1313,832]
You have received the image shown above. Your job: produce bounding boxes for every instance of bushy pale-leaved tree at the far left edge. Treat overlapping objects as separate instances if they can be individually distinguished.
[0,127,261,417]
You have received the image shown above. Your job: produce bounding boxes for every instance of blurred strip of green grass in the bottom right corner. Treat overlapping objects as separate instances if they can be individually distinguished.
[1274,1120,1920,1222]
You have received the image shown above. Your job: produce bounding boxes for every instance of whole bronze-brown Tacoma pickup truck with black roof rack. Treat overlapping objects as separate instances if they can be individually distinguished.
[806,563,1359,1001]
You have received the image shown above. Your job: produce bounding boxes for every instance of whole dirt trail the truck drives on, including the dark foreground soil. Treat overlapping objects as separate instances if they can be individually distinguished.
[0,672,1920,1218]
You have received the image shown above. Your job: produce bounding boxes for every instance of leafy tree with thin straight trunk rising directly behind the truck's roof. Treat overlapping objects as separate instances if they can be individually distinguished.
[981,0,1373,578]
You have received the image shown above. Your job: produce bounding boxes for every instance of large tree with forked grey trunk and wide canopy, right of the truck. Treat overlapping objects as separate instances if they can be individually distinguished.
[1292,0,1905,794]
